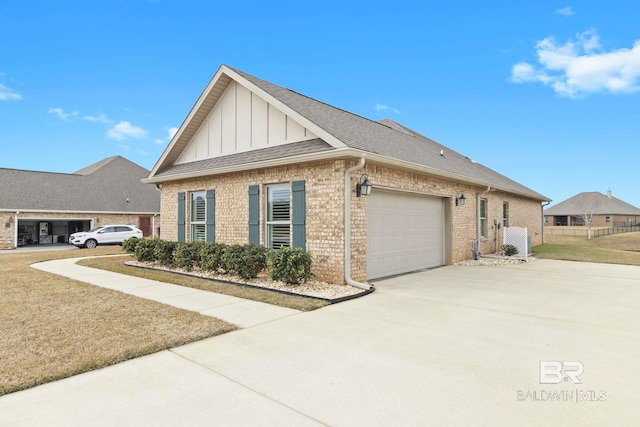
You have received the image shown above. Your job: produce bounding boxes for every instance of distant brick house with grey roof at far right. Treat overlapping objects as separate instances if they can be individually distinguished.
[544,190,640,227]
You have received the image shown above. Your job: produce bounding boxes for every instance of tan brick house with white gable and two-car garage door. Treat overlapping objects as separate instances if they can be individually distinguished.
[145,65,548,283]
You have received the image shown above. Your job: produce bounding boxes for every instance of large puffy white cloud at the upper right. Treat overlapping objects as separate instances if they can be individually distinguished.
[511,30,640,97]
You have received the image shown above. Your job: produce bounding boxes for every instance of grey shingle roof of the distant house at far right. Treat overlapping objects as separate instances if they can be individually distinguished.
[544,191,640,216]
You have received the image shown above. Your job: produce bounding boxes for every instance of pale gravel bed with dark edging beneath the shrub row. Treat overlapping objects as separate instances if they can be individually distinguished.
[125,261,374,304]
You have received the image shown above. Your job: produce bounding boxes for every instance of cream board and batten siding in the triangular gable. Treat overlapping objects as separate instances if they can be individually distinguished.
[176,82,317,164]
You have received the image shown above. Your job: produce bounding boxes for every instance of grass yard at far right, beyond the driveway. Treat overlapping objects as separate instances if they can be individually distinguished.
[532,232,640,265]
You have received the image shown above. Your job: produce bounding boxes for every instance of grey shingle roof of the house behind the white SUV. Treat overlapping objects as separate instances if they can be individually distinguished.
[0,156,160,213]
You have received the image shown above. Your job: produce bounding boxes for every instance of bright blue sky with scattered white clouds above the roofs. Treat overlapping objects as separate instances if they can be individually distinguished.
[0,0,640,207]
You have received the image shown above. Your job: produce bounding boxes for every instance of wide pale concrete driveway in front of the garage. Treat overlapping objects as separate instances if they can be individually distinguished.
[0,260,640,426]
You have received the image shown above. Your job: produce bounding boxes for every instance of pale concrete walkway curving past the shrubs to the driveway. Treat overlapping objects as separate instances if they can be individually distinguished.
[32,258,300,328]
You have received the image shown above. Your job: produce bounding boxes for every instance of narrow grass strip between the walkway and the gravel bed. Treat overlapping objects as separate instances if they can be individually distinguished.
[78,255,329,311]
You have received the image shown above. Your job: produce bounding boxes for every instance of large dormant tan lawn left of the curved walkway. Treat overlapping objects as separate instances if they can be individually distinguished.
[0,246,236,395]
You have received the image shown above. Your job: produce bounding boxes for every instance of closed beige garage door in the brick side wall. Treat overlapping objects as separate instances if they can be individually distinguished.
[367,190,444,279]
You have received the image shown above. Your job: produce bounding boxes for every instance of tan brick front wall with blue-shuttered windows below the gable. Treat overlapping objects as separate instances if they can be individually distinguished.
[161,160,344,283]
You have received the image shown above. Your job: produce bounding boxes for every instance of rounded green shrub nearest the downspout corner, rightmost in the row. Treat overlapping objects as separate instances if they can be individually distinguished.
[267,247,311,285]
